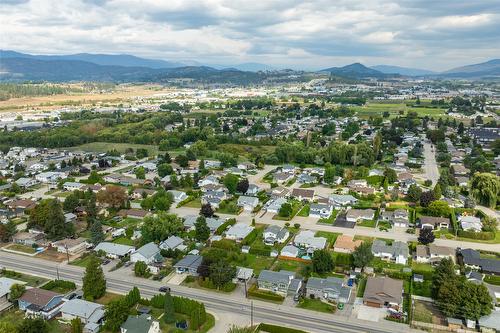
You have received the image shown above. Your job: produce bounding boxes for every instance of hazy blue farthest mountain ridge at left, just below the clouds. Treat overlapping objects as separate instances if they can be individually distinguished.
[0,50,186,68]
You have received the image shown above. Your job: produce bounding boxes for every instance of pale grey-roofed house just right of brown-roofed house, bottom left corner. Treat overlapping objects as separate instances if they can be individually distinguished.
[61,298,105,333]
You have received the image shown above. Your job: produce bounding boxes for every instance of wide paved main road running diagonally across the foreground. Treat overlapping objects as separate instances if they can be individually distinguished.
[0,252,417,333]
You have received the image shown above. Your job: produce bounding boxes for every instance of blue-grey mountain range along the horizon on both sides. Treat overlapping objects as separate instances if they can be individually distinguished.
[0,50,500,84]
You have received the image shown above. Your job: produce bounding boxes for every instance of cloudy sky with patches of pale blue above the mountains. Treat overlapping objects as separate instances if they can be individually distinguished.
[0,0,500,71]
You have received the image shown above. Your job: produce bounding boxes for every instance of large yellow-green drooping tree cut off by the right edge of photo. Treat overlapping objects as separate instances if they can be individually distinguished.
[470,173,500,208]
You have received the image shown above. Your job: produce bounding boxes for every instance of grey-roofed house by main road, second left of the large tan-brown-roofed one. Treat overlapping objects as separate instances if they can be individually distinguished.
[257,270,302,296]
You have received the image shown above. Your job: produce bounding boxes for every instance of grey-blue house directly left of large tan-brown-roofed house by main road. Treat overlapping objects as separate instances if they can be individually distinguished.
[306,277,351,303]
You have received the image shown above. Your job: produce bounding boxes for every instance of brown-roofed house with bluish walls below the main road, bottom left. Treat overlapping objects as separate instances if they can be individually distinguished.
[18,288,64,320]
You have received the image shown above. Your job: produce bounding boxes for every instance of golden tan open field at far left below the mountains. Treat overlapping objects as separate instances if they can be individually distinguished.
[0,85,174,111]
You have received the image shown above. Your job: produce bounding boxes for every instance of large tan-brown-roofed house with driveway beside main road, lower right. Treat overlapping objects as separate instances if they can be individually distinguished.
[363,276,403,310]
